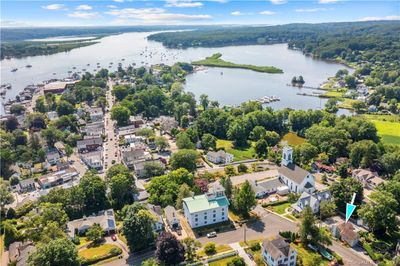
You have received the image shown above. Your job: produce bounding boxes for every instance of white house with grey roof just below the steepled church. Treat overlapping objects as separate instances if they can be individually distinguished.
[291,190,332,213]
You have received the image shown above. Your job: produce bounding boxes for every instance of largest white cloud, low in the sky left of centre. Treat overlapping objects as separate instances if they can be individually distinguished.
[105,8,212,24]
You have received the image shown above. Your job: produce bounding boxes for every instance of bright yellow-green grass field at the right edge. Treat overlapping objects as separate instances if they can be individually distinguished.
[363,115,400,145]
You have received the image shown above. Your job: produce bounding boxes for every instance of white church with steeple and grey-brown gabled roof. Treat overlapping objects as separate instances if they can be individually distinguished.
[278,146,315,193]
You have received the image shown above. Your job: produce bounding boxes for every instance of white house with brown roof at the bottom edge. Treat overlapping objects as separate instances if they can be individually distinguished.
[262,236,297,266]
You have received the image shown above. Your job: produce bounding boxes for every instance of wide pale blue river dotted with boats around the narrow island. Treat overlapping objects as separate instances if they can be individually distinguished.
[0,32,348,113]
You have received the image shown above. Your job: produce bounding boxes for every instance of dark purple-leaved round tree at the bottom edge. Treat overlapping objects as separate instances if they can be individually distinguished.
[155,232,185,265]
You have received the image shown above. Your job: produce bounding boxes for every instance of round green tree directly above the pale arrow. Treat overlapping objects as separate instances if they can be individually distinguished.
[331,178,364,212]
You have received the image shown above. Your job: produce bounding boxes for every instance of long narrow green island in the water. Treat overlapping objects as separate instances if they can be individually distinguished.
[192,53,283,74]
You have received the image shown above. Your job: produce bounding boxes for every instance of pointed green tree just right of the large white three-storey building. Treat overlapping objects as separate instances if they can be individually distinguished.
[234,180,257,218]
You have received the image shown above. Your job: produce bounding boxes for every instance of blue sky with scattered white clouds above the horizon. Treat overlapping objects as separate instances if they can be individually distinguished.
[0,0,400,27]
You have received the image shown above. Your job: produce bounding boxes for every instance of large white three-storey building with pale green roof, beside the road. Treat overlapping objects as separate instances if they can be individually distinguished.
[183,184,229,228]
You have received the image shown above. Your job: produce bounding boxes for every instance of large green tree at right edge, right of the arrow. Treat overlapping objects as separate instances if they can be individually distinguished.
[358,191,399,233]
